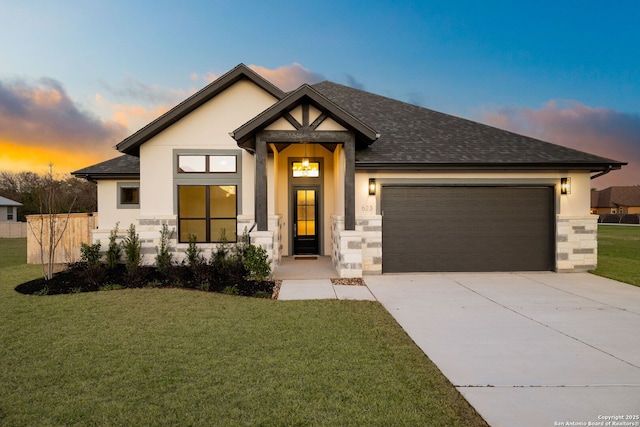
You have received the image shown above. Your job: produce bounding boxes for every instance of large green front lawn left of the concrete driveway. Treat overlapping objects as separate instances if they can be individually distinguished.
[0,239,485,426]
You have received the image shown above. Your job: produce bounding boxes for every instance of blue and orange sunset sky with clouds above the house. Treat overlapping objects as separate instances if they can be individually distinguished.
[0,0,640,189]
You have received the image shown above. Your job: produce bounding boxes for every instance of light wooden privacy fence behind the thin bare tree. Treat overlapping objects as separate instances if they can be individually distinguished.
[27,213,98,264]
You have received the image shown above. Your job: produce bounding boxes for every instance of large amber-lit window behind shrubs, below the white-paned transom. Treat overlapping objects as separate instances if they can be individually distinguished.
[178,185,238,243]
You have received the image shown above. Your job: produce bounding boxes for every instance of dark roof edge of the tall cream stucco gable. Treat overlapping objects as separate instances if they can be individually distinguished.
[116,64,285,156]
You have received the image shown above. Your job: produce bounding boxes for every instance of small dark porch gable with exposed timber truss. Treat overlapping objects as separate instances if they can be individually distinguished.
[232,84,379,151]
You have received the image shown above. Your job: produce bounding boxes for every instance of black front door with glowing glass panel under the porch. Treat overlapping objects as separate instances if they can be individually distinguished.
[293,187,319,255]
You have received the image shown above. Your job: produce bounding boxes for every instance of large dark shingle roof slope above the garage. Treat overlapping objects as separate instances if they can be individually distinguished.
[313,81,624,171]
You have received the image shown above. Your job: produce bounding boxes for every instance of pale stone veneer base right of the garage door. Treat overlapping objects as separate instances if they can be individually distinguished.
[556,215,598,273]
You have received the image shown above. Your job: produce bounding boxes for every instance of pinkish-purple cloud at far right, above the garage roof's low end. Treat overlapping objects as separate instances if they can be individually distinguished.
[480,100,640,188]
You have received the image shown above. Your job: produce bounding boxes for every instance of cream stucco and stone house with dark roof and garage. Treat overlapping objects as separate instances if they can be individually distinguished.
[74,64,626,276]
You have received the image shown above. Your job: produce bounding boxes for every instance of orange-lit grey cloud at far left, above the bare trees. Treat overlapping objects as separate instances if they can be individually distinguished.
[0,78,126,154]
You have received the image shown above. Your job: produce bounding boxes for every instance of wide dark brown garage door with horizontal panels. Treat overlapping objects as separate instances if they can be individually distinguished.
[381,186,555,273]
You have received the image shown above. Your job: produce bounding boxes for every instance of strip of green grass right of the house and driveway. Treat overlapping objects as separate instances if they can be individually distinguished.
[593,225,640,286]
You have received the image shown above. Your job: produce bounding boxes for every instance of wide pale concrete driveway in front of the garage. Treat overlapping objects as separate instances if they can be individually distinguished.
[365,273,640,427]
